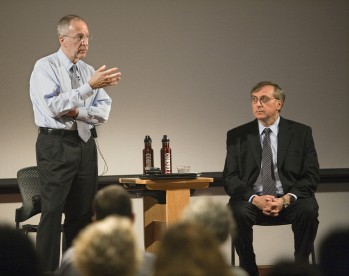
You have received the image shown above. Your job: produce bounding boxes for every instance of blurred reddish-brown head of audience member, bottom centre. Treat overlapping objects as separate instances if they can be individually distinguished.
[154,222,231,276]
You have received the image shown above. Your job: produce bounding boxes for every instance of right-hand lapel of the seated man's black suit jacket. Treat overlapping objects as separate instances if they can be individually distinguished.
[277,117,293,169]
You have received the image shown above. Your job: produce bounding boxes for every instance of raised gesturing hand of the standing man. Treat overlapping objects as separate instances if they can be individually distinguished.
[88,65,121,89]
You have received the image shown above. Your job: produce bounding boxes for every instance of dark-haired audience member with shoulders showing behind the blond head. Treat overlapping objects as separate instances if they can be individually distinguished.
[56,185,155,276]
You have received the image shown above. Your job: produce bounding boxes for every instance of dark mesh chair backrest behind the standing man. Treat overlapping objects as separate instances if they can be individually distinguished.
[16,166,41,222]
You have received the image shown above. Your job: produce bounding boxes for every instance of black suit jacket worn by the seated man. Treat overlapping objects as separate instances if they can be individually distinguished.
[223,117,320,200]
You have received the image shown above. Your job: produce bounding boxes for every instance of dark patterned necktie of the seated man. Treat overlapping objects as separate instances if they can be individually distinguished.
[261,128,276,196]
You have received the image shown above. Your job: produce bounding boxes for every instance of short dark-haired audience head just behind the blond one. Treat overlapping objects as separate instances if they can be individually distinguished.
[93,185,134,221]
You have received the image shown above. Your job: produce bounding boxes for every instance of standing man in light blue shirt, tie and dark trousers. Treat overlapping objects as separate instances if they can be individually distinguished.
[30,15,121,271]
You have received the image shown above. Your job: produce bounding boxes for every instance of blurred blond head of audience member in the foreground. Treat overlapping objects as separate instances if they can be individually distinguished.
[74,216,139,276]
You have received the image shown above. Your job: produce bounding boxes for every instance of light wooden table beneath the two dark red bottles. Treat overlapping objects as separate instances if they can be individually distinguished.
[119,177,213,252]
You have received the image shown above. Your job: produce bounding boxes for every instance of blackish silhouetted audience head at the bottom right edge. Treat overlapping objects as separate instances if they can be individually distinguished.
[319,227,349,276]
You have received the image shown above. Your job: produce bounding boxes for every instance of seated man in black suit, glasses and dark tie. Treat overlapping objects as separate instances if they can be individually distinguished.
[223,81,320,275]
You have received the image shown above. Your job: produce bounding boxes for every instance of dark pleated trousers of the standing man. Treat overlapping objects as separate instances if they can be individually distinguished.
[36,133,98,271]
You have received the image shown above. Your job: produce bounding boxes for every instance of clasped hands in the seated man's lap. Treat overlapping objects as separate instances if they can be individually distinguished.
[252,195,283,217]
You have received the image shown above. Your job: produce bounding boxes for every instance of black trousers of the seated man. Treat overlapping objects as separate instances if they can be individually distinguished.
[229,197,319,275]
